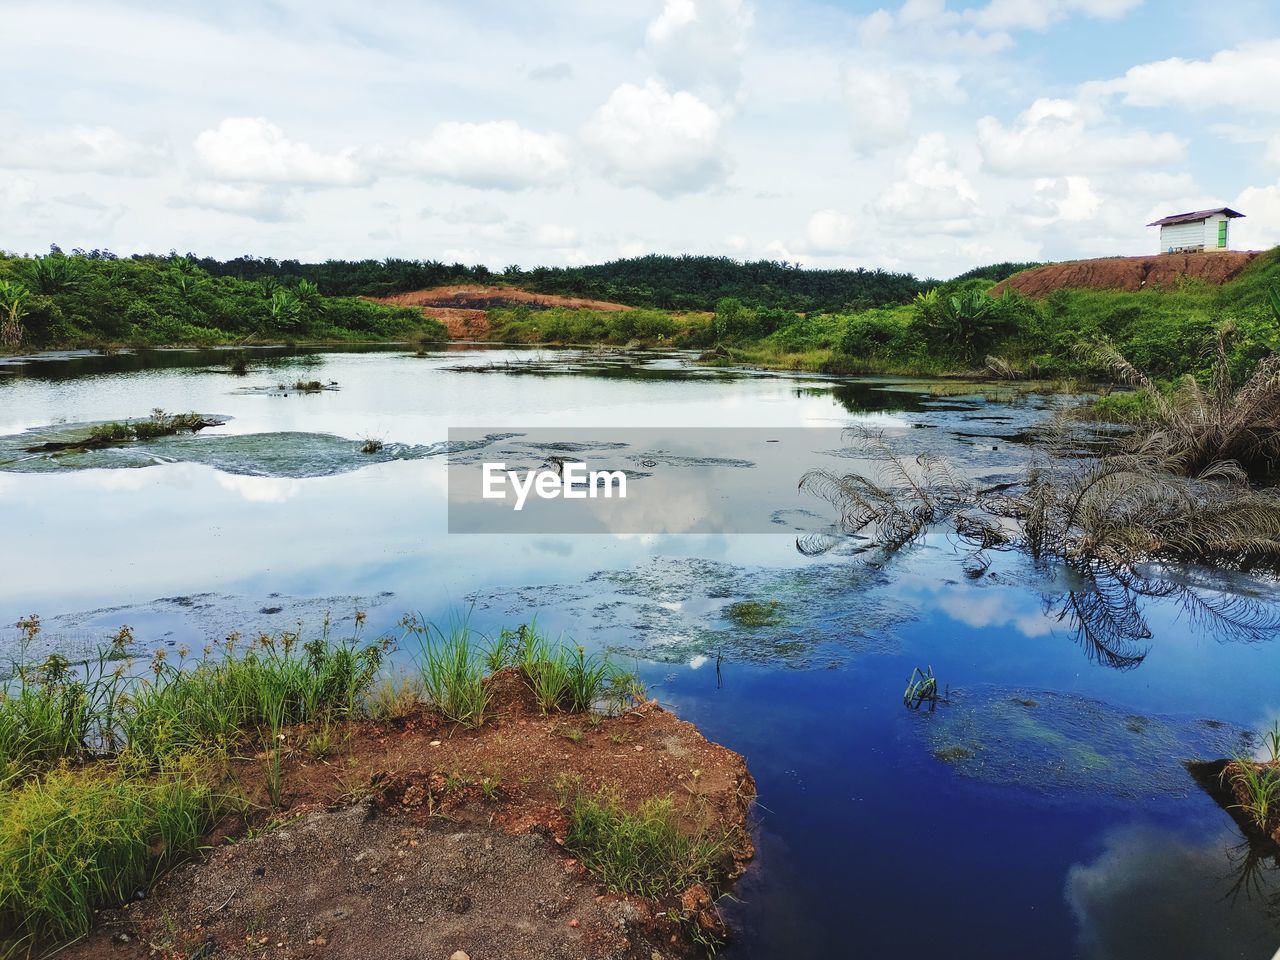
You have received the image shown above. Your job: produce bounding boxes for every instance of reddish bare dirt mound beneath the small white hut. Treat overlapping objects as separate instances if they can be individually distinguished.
[991,251,1258,297]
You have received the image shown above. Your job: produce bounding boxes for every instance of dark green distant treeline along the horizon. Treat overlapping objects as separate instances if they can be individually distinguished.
[189,253,1025,314]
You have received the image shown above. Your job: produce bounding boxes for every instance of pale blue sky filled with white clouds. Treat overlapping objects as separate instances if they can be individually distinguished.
[0,0,1280,278]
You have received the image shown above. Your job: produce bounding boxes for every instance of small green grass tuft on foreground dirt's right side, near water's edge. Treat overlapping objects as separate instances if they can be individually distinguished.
[564,794,727,900]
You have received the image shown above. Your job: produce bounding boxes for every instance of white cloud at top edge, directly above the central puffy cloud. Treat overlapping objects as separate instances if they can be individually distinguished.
[645,0,753,97]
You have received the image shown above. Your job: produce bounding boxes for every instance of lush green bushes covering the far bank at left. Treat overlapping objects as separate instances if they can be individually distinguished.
[0,250,445,353]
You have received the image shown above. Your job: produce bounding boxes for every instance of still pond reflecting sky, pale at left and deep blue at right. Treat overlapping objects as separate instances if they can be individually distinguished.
[0,349,1280,959]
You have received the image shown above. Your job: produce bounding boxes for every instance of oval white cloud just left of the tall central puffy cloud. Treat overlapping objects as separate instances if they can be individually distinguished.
[383,120,570,191]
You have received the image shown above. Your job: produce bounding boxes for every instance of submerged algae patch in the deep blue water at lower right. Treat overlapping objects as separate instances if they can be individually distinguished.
[918,689,1252,799]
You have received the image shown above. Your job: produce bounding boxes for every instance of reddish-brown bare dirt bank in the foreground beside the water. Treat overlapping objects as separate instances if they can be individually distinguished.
[74,671,755,960]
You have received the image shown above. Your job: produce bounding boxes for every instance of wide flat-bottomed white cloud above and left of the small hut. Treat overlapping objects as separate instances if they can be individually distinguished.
[978,99,1185,177]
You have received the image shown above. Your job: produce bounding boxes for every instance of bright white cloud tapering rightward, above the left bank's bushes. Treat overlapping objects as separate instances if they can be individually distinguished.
[193,116,369,187]
